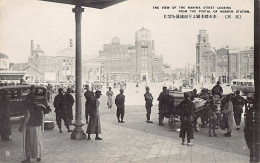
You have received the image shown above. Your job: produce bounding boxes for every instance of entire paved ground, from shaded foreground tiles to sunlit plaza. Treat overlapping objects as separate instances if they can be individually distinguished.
[0,85,249,163]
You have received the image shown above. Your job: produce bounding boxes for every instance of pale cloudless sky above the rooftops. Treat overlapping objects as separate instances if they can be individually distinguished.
[0,0,254,68]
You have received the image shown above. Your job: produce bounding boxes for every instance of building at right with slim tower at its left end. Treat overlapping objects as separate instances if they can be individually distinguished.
[196,30,254,83]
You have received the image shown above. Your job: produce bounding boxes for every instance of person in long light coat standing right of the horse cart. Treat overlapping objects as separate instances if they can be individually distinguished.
[222,94,233,137]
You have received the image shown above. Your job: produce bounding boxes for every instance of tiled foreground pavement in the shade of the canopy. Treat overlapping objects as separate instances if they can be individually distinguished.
[0,119,249,163]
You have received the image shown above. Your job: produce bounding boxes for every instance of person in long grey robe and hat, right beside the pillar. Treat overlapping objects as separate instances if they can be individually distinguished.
[87,91,102,140]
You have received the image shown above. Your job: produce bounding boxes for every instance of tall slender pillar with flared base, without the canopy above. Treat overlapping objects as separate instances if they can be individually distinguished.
[71,5,86,139]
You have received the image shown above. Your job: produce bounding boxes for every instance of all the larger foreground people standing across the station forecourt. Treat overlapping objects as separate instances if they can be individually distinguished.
[0,82,255,163]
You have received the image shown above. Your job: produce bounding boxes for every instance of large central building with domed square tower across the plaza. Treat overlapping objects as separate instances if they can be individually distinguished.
[99,28,164,81]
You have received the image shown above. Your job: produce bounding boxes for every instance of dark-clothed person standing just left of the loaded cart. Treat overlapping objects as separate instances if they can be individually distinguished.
[157,87,168,126]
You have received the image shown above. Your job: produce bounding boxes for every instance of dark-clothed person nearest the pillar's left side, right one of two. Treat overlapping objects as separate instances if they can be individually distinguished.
[65,88,75,124]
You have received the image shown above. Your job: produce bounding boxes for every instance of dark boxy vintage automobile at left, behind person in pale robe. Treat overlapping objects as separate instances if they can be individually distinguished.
[0,85,51,117]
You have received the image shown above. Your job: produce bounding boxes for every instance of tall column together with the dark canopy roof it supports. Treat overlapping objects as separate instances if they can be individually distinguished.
[41,0,125,139]
